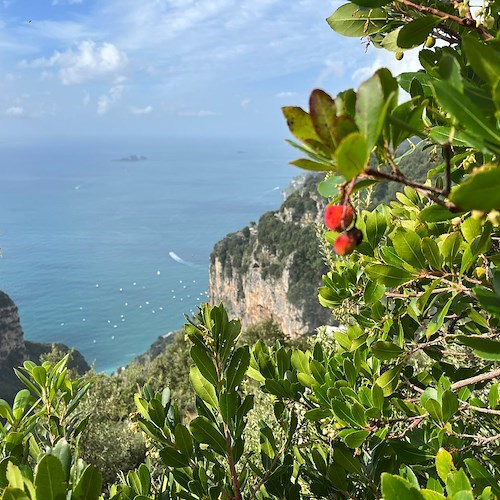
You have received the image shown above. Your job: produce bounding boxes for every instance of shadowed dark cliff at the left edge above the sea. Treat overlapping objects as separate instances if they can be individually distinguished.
[0,291,90,400]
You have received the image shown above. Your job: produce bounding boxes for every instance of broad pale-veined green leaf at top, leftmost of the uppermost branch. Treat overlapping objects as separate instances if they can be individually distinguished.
[326,3,387,37]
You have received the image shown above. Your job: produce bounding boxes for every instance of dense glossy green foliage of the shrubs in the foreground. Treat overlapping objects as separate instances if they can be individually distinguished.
[0,0,500,500]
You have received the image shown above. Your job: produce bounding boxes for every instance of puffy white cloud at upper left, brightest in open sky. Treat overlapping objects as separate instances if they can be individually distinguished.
[23,40,127,85]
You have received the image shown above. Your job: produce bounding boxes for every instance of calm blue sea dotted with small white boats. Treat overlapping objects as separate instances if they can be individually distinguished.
[0,139,300,372]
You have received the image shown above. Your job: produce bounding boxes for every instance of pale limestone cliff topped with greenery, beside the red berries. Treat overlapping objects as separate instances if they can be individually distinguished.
[209,177,332,337]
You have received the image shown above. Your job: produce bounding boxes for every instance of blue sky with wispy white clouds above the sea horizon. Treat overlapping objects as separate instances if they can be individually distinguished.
[0,0,422,141]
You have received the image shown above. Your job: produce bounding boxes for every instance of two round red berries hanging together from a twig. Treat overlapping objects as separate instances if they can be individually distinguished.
[325,204,363,255]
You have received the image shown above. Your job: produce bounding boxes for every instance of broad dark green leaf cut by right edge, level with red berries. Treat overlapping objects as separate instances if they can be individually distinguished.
[450,168,500,211]
